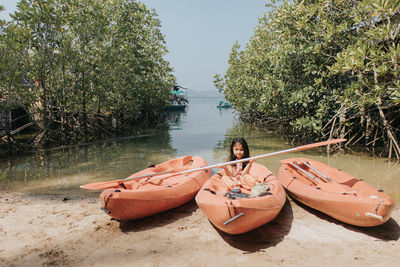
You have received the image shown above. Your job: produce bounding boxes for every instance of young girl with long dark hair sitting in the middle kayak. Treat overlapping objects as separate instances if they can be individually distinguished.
[221,137,256,190]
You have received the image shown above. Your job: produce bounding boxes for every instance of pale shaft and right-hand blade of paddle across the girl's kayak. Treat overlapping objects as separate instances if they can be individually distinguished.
[121,139,346,181]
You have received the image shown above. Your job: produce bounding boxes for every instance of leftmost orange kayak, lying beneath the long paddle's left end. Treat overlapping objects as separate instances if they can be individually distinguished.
[100,156,210,220]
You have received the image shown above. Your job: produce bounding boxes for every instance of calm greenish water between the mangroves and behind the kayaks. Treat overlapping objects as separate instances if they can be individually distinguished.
[0,99,400,203]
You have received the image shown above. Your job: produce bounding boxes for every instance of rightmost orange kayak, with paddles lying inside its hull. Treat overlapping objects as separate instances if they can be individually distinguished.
[278,158,394,226]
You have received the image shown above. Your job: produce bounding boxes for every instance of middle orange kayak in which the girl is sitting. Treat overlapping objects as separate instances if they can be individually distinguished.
[196,163,286,234]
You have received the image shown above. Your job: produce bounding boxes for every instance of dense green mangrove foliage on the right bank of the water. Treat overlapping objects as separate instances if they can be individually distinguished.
[214,0,400,157]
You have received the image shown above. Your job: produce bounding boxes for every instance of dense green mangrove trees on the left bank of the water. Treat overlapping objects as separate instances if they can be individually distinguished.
[0,0,175,147]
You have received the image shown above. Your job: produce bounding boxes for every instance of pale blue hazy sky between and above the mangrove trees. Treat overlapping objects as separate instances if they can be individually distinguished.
[0,0,268,91]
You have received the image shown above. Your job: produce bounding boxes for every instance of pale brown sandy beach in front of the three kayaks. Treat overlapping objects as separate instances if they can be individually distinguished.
[0,192,400,266]
